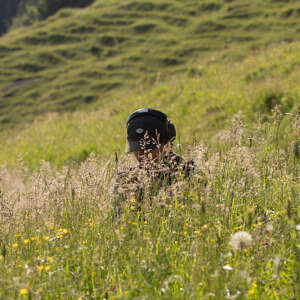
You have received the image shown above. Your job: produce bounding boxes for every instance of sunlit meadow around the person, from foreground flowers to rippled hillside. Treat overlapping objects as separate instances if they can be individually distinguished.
[0,43,300,299]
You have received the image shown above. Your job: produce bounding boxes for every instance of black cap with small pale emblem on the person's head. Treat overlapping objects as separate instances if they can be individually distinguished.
[125,109,168,152]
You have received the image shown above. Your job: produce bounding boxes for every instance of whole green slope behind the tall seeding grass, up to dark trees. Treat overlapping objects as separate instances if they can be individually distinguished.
[0,0,300,167]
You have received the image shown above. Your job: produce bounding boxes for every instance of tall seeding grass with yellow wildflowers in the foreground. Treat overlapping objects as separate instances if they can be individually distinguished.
[0,112,300,299]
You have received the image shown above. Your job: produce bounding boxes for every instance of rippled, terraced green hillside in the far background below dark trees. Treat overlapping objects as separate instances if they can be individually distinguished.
[0,0,300,128]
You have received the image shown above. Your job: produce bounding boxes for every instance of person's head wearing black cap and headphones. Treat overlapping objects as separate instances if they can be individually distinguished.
[126,108,176,162]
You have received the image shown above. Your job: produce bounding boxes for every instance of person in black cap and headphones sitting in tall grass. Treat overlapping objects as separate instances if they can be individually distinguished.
[113,108,194,214]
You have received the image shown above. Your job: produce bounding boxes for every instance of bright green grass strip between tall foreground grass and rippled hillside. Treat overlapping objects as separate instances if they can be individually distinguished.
[0,43,300,168]
